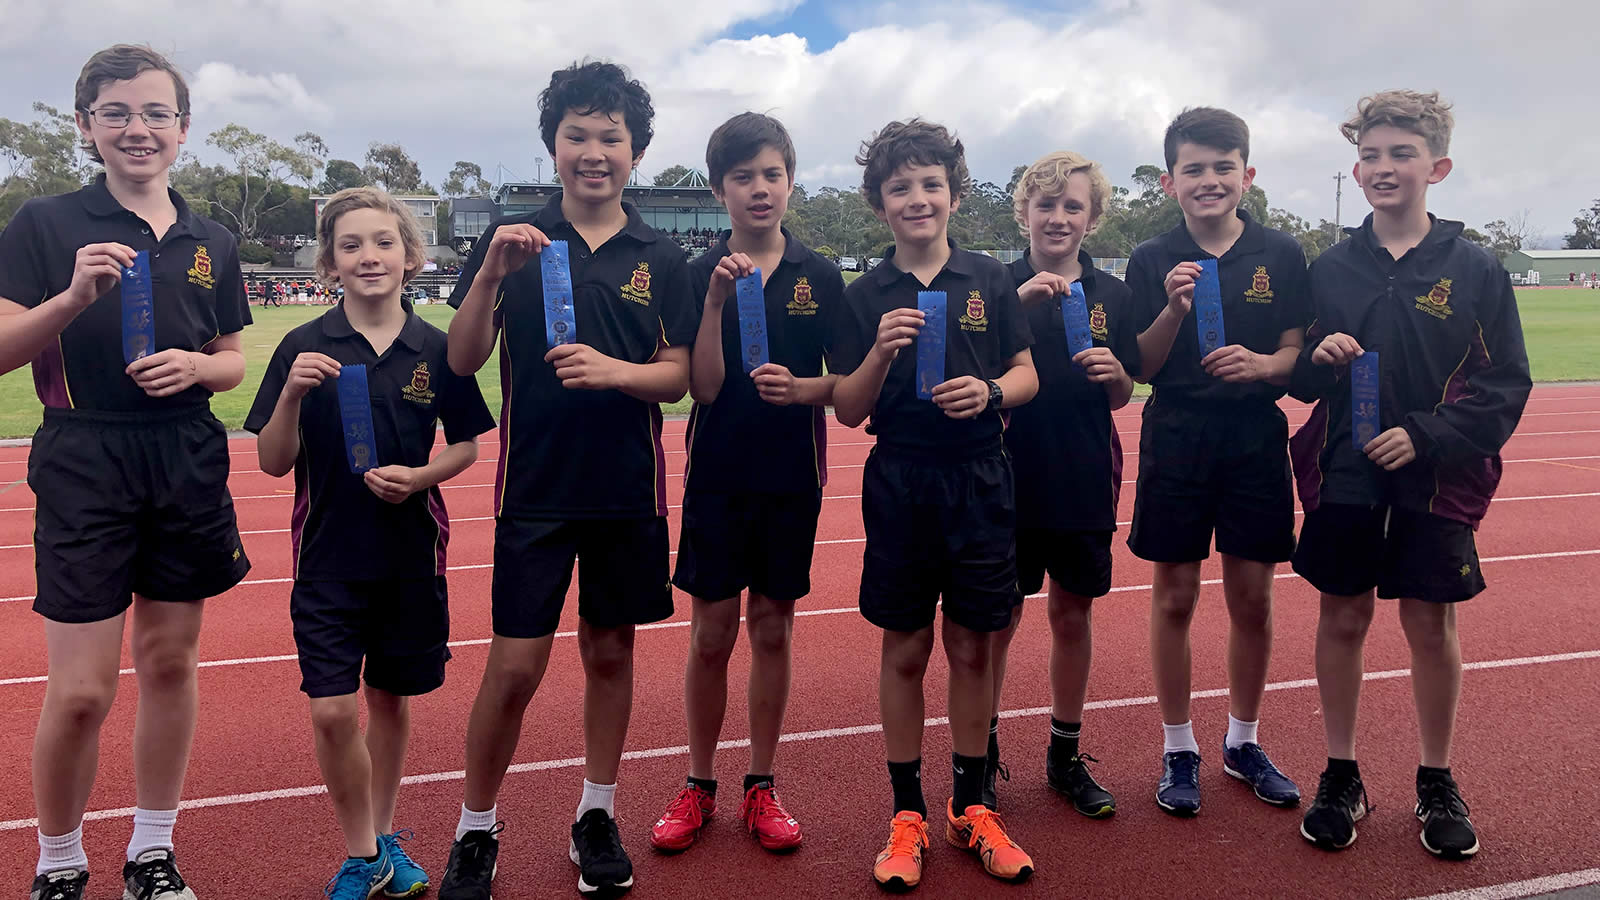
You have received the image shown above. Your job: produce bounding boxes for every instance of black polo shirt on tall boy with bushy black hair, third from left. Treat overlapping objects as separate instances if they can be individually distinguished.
[450,194,699,519]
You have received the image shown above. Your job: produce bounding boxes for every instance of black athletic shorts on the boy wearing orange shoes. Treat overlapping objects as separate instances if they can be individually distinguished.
[861,447,1022,631]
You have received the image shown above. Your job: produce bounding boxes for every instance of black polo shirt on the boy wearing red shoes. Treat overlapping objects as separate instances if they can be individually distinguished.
[685,229,845,493]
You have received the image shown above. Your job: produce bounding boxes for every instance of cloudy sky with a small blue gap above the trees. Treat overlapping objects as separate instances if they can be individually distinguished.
[0,0,1600,245]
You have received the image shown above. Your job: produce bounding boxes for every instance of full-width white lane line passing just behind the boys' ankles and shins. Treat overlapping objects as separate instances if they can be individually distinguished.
[0,640,1600,832]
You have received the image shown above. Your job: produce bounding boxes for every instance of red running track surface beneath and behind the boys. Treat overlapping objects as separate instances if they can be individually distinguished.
[0,386,1600,900]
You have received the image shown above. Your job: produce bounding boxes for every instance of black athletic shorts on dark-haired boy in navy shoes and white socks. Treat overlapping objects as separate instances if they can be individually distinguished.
[1128,400,1294,562]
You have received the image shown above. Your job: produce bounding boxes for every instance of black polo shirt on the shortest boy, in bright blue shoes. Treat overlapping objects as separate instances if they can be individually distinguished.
[245,304,494,581]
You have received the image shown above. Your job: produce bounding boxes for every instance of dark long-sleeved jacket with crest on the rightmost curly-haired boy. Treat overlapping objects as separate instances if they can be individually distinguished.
[1290,216,1533,528]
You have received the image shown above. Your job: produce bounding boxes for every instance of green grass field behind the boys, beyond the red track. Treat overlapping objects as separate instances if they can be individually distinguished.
[0,286,1600,437]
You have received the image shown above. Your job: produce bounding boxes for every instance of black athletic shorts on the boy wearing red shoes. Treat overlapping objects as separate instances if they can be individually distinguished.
[672,490,822,604]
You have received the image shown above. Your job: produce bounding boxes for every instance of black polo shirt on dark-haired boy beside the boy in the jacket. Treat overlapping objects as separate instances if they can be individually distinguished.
[1128,210,1312,405]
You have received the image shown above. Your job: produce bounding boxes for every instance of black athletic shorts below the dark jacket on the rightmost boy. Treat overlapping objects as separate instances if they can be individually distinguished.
[1294,503,1485,604]
